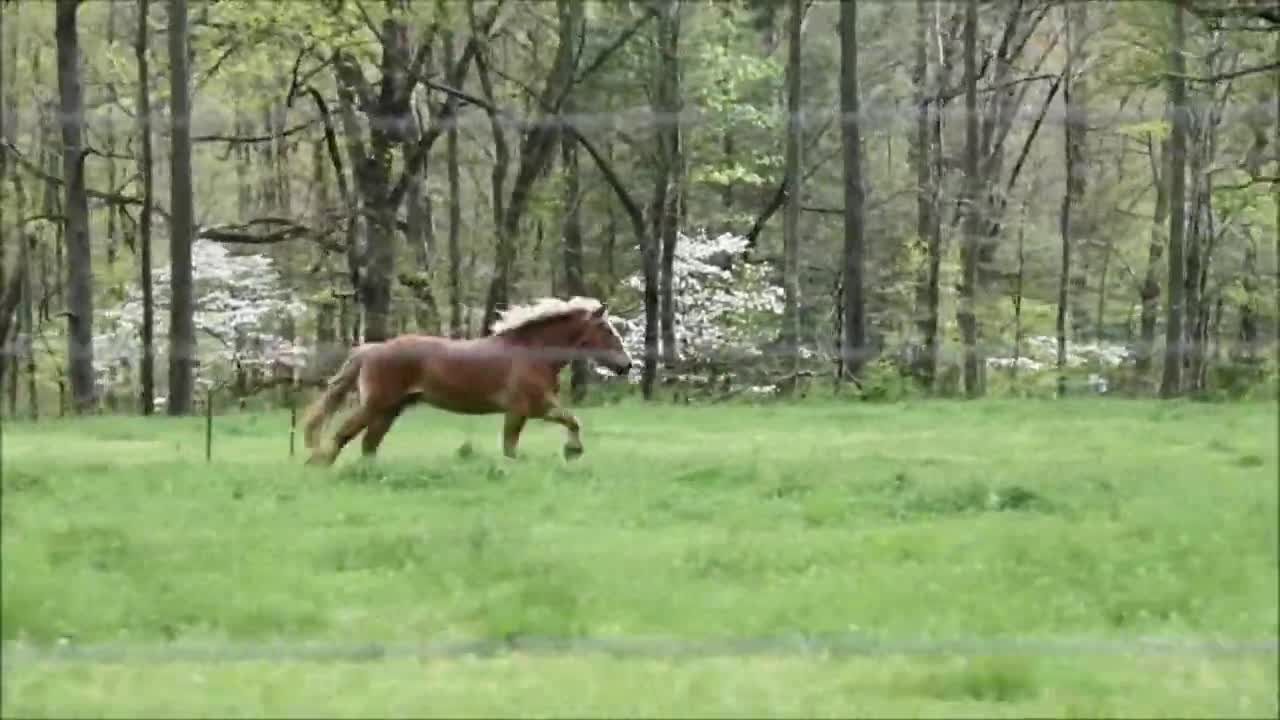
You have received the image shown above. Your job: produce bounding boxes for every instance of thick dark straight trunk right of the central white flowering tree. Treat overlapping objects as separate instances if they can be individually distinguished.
[840,0,870,380]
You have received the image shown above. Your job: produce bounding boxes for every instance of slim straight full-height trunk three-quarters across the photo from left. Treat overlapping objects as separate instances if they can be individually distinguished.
[956,0,983,397]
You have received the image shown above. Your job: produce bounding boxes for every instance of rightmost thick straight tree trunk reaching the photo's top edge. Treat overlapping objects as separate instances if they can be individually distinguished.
[1160,0,1189,397]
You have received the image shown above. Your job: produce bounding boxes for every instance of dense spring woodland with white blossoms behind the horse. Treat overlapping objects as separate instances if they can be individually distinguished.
[0,0,1280,419]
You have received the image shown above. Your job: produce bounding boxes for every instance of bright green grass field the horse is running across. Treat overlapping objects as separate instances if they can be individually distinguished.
[3,400,1280,717]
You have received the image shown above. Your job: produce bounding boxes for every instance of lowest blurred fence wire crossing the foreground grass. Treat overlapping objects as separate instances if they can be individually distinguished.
[0,633,1280,670]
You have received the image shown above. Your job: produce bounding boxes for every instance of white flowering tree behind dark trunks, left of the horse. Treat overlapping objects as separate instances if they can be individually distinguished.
[93,240,305,397]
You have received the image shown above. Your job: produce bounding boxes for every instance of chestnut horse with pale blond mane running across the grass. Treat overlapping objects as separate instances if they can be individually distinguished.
[303,297,632,466]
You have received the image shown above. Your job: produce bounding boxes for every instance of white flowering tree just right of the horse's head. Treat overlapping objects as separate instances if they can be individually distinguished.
[621,232,782,379]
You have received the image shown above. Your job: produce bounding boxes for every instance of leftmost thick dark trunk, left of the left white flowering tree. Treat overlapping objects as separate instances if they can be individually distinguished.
[55,0,97,414]
